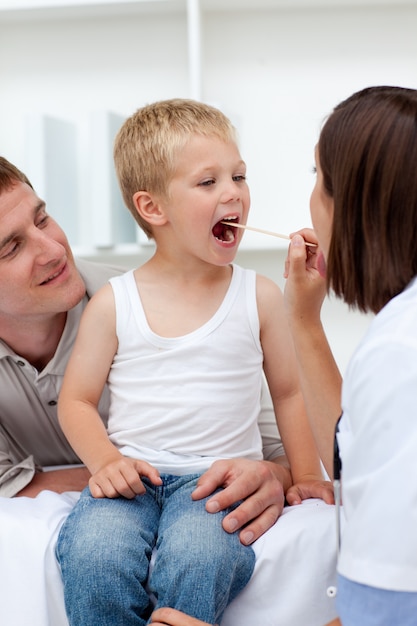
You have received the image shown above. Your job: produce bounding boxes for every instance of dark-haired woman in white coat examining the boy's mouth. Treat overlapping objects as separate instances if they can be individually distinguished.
[285,87,417,626]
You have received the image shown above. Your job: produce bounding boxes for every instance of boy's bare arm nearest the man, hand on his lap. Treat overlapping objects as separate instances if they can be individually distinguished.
[58,285,158,498]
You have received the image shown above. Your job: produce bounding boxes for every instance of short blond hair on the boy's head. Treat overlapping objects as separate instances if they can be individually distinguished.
[114,98,236,237]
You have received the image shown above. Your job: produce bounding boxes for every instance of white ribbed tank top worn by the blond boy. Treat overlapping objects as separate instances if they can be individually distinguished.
[108,265,263,475]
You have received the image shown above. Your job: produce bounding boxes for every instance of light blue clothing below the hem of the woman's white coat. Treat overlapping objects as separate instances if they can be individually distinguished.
[336,574,417,626]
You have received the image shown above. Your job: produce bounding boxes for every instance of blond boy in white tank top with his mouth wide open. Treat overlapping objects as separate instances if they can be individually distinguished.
[57,100,328,626]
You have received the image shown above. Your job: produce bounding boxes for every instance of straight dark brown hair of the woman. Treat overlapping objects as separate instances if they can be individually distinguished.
[318,86,417,313]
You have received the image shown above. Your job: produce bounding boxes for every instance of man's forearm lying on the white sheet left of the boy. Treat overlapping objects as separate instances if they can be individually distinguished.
[15,467,90,498]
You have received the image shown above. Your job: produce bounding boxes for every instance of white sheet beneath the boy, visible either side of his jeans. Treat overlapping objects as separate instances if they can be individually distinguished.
[0,491,336,626]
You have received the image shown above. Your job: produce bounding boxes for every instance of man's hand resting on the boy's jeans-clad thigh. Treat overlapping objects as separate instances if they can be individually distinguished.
[193,459,291,545]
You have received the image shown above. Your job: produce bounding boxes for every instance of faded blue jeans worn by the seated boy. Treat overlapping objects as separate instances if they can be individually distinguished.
[57,474,255,626]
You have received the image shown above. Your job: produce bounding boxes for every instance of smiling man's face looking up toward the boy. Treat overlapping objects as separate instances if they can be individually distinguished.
[0,182,85,320]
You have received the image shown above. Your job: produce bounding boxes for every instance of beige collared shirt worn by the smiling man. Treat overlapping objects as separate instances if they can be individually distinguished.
[0,261,122,497]
